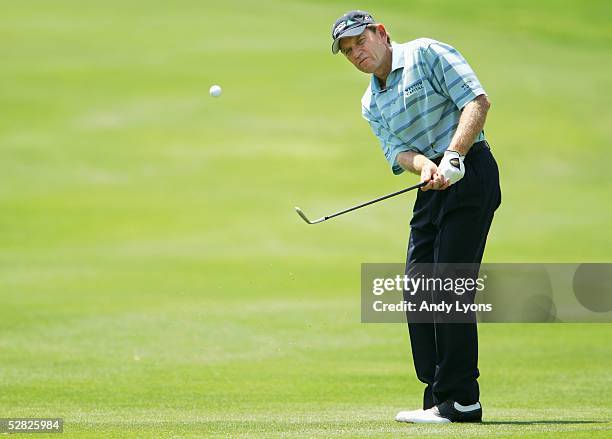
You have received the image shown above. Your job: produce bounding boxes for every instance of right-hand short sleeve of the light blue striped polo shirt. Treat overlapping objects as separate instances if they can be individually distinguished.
[423,42,486,109]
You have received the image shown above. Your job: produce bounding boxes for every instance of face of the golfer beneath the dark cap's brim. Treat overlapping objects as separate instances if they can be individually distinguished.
[340,28,387,73]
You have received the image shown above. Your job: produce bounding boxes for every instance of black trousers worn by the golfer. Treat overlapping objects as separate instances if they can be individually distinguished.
[406,141,501,409]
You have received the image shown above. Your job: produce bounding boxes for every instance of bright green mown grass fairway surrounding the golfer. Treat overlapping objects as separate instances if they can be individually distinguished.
[0,0,612,438]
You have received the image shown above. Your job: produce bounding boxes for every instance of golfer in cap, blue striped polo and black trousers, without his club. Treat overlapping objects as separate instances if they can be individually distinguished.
[332,11,501,423]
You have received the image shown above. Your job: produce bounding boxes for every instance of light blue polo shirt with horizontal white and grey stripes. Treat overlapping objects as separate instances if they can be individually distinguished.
[361,38,485,175]
